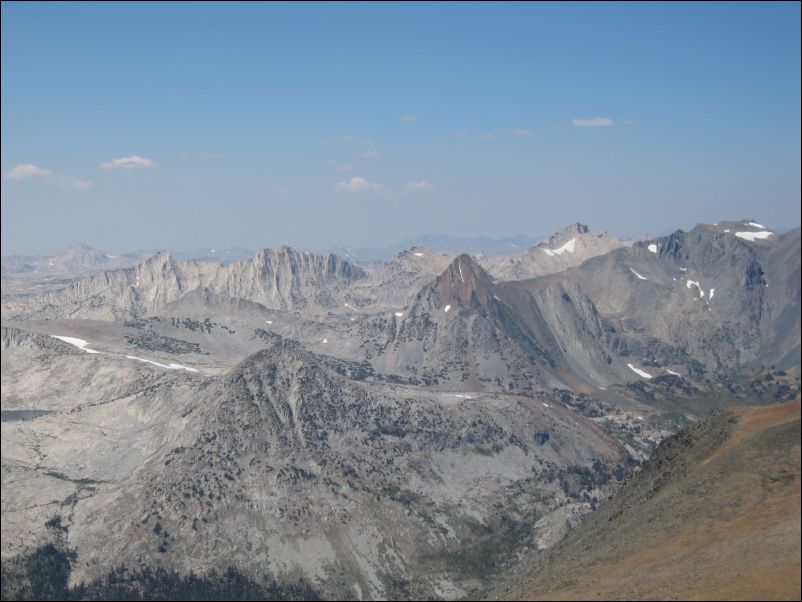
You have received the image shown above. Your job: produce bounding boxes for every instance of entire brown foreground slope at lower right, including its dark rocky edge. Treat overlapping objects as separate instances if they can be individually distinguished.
[495,398,802,600]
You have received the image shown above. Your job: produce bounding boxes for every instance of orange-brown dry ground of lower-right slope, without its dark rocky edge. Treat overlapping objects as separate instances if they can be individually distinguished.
[510,398,802,600]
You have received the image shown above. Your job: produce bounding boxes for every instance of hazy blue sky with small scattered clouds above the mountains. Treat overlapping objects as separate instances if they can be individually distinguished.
[0,2,801,256]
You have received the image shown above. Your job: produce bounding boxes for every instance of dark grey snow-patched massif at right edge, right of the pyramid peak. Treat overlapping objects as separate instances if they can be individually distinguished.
[564,222,800,375]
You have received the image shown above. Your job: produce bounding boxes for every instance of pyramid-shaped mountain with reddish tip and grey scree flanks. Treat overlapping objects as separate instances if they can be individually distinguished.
[359,255,561,392]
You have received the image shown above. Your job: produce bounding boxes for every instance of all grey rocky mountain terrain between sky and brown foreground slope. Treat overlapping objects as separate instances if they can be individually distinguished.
[2,222,800,599]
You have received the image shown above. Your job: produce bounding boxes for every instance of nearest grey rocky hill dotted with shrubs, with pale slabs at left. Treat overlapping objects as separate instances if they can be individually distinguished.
[2,329,626,598]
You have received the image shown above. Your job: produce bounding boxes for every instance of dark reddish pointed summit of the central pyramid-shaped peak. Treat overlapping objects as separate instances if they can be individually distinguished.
[429,253,495,313]
